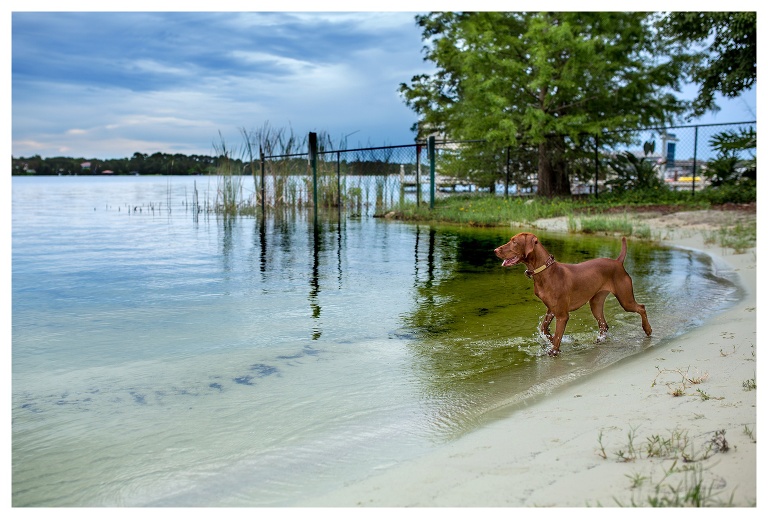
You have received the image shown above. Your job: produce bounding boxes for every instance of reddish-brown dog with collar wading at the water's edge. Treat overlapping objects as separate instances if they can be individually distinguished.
[494,232,651,356]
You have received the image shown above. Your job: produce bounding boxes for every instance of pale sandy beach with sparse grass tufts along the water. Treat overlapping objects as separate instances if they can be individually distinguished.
[300,211,757,507]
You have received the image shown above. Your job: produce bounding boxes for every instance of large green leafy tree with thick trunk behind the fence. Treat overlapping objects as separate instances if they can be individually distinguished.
[400,12,690,196]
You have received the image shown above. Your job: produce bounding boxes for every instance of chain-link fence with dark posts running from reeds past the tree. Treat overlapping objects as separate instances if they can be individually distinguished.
[253,121,756,216]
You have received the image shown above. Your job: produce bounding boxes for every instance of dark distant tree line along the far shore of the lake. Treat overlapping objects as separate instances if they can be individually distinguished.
[11,152,238,175]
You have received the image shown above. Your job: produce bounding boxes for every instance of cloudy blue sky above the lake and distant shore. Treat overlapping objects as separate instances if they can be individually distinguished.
[11,3,756,158]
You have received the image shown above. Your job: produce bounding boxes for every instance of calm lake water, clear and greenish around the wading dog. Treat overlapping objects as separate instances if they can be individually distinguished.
[12,177,740,506]
